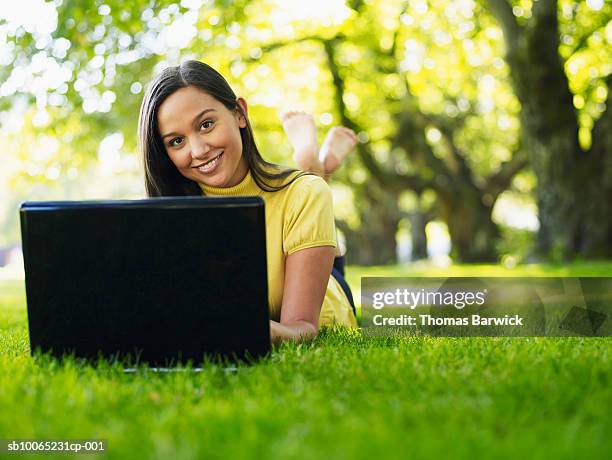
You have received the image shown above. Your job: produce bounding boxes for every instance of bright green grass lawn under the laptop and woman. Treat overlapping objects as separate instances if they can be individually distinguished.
[0,263,612,459]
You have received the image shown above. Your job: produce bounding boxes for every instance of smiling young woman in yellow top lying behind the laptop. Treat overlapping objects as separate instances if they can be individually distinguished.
[139,61,357,342]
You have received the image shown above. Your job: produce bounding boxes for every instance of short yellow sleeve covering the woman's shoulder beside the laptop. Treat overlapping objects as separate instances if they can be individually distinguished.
[283,176,336,255]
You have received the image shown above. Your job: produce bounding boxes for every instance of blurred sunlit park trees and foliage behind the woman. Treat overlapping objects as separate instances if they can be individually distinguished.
[0,0,612,275]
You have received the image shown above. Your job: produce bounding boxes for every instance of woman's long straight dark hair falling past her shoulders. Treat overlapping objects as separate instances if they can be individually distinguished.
[138,61,310,197]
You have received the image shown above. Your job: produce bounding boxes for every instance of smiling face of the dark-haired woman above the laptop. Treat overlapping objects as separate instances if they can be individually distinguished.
[157,86,248,187]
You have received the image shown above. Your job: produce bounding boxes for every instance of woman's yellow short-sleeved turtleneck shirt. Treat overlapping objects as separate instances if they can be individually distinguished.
[200,167,357,327]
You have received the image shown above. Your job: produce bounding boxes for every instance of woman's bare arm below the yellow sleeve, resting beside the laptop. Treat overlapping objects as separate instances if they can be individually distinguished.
[270,246,336,343]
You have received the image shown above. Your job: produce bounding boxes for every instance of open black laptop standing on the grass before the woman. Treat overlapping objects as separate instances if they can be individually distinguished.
[20,197,270,367]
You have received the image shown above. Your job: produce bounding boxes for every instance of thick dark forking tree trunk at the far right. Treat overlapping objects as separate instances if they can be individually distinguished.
[489,0,612,258]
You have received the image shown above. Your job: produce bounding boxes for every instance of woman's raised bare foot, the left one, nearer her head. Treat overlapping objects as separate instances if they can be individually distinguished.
[281,112,324,175]
